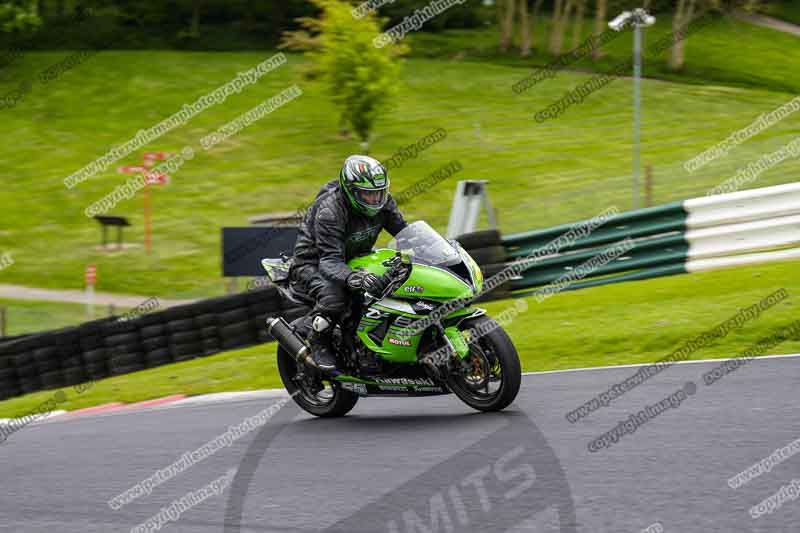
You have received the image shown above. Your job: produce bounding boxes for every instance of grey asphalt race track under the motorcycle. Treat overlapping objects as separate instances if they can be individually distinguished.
[0,357,800,533]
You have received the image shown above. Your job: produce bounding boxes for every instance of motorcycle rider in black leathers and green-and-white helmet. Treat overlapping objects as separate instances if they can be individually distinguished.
[290,155,407,372]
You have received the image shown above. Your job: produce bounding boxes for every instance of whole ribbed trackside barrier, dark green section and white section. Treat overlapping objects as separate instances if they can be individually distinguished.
[476,183,800,297]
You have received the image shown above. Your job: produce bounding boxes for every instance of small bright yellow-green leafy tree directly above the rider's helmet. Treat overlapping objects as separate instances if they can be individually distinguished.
[281,0,406,151]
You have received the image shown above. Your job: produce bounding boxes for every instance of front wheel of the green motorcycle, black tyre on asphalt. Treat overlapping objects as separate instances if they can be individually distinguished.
[447,316,522,411]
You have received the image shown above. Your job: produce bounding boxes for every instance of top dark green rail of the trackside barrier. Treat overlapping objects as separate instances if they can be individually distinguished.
[502,202,688,258]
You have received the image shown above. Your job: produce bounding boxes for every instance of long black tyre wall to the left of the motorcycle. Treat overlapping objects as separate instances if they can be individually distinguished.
[0,287,307,400]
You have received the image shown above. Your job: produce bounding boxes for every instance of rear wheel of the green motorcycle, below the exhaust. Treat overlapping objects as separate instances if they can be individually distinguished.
[278,346,358,417]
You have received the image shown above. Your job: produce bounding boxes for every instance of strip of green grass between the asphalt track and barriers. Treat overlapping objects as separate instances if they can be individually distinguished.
[0,263,800,417]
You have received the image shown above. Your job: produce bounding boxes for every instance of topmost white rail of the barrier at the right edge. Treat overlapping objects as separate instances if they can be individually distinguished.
[683,183,800,229]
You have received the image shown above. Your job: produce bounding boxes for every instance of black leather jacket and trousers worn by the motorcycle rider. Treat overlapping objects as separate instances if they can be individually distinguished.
[291,180,407,322]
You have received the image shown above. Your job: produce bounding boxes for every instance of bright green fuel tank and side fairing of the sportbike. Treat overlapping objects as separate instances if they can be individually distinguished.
[348,249,476,363]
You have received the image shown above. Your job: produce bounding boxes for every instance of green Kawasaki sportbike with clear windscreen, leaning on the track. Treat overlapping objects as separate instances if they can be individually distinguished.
[262,221,521,417]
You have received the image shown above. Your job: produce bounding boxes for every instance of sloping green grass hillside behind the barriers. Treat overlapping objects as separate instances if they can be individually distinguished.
[0,22,800,298]
